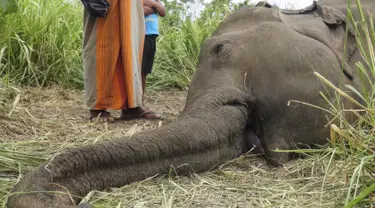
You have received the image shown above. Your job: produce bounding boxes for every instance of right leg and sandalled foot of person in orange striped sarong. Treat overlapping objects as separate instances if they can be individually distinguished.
[114,0,160,120]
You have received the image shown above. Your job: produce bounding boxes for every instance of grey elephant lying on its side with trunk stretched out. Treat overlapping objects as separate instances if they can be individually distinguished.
[8,0,374,208]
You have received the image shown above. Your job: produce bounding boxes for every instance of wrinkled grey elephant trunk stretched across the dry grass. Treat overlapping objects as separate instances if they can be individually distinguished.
[8,90,252,208]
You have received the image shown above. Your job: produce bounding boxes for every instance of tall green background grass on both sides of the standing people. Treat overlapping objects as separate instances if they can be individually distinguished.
[0,0,253,89]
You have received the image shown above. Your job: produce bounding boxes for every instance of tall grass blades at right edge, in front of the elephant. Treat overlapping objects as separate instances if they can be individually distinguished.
[322,0,375,208]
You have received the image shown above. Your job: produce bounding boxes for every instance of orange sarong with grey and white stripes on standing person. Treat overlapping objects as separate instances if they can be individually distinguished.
[83,0,145,110]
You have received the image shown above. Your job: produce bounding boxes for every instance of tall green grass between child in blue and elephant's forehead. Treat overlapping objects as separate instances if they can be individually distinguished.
[149,0,233,88]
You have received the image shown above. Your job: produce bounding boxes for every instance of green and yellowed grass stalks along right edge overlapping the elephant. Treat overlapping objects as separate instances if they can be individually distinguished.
[294,0,375,208]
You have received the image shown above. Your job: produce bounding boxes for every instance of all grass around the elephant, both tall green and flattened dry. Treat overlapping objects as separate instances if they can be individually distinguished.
[0,0,375,208]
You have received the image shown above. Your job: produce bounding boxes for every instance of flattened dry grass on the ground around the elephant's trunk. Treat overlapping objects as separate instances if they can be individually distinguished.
[0,89,370,207]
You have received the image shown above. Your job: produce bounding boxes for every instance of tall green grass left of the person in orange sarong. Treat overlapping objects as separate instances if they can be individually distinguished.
[0,0,83,87]
